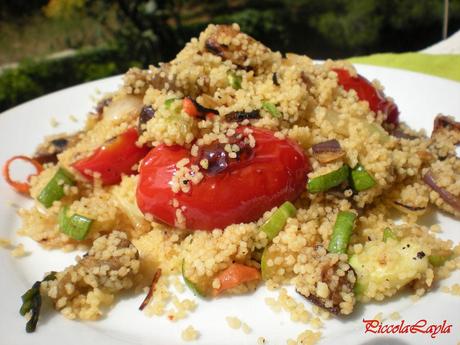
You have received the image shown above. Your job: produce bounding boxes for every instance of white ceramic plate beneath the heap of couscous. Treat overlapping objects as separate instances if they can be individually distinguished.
[0,65,460,345]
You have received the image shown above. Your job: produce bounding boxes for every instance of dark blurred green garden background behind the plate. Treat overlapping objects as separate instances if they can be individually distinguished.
[0,0,460,111]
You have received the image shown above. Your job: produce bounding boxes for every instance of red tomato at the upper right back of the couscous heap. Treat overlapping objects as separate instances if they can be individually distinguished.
[333,68,399,125]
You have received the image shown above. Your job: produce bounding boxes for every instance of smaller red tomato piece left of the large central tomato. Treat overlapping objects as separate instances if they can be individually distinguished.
[72,128,149,185]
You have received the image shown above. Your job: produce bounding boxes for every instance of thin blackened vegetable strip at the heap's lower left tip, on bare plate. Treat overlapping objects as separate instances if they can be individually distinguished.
[19,272,56,333]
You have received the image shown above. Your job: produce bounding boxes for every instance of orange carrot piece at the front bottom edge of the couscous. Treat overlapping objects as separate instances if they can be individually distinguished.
[213,263,261,295]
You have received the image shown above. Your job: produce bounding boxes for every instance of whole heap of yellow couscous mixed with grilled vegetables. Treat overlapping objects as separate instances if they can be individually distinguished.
[4,24,460,343]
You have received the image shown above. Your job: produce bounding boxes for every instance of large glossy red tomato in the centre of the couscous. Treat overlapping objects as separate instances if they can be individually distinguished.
[136,127,310,230]
